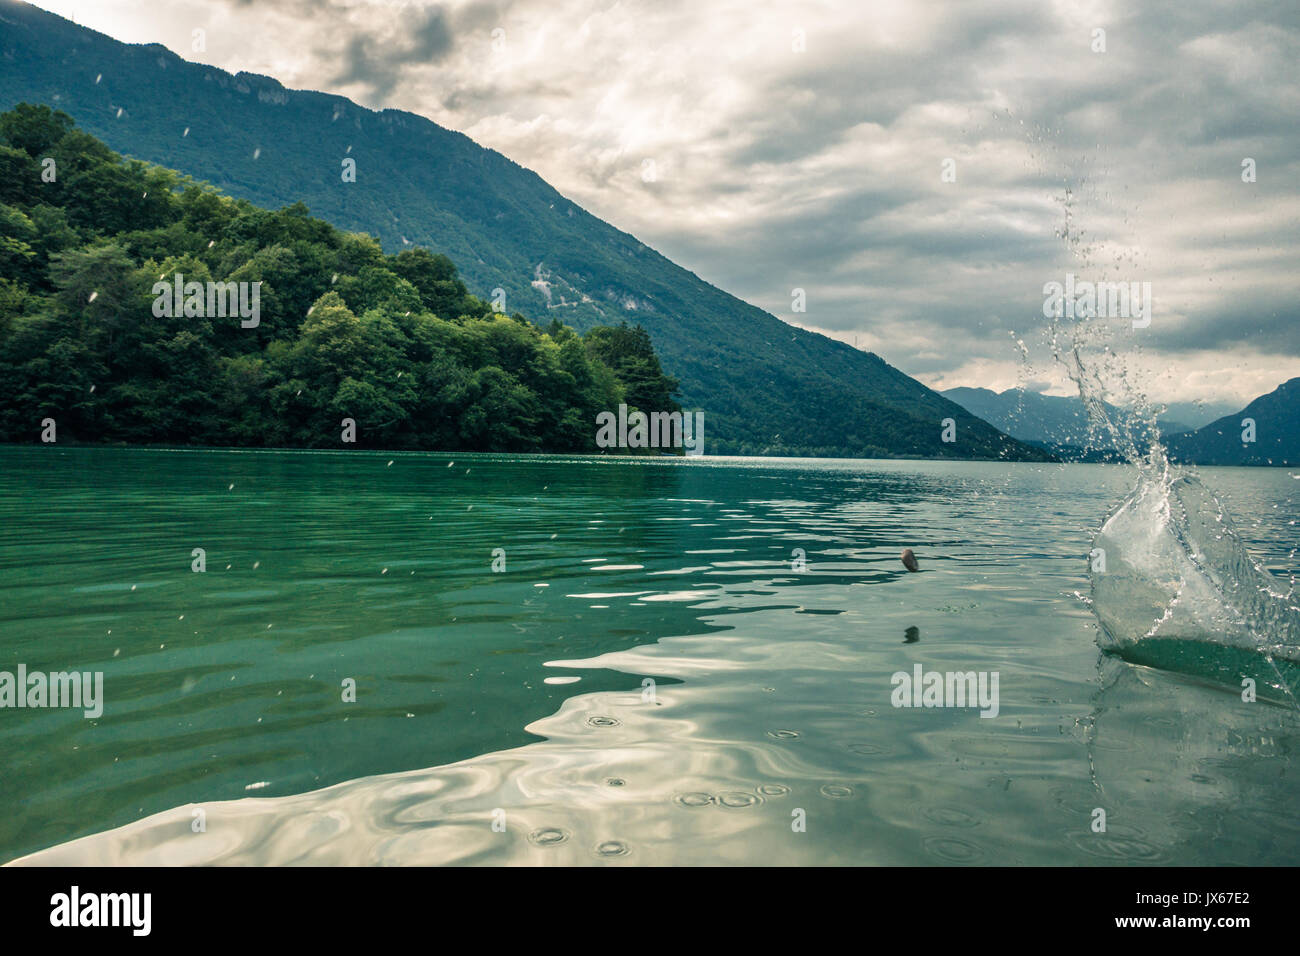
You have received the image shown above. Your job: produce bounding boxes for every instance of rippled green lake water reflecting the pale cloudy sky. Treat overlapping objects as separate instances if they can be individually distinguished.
[0,447,1300,865]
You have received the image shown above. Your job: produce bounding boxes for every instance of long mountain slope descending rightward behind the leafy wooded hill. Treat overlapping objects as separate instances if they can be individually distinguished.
[0,0,1049,460]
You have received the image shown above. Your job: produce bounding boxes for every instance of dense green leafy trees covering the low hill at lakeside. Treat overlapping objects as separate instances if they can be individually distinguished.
[0,104,680,451]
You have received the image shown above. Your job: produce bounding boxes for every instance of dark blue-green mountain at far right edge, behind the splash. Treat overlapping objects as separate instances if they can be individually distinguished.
[1169,378,1300,467]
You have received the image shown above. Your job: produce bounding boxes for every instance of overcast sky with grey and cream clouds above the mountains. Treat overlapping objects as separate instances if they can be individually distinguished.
[30,0,1300,407]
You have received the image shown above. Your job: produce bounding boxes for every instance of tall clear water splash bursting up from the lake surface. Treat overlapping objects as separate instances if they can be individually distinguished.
[1049,171,1300,709]
